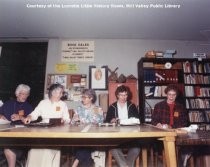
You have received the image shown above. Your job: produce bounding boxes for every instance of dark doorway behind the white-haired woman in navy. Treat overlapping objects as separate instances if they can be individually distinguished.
[0,42,48,107]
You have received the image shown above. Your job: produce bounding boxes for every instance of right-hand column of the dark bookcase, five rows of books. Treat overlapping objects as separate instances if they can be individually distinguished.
[183,59,210,123]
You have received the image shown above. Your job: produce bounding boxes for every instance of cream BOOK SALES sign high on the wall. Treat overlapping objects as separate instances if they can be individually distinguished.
[61,41,94,62]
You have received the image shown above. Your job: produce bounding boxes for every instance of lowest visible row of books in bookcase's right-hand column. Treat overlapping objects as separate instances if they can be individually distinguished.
[189,110,210,122]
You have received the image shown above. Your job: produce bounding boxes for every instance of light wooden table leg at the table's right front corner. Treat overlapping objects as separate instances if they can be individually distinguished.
[163,137,177,167]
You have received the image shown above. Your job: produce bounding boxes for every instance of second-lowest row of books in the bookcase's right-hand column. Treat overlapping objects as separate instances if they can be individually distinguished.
[186,99,210,109]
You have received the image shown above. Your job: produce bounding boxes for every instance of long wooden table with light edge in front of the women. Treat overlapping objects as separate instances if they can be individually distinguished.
[0,124,177,167]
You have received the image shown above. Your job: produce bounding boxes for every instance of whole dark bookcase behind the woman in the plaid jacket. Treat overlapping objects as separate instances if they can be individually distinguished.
[138,58,210,124]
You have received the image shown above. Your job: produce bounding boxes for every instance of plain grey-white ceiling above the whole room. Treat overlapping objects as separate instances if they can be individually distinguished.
[0,0,210,41]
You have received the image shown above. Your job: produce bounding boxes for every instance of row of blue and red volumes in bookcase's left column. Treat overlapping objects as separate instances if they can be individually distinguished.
[144,69,178,83]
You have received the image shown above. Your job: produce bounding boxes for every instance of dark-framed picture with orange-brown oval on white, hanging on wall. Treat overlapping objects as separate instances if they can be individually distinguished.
[89,66,108,90]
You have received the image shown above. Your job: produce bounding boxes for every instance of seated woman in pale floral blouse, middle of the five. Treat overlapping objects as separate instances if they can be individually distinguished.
[71,89,104,167]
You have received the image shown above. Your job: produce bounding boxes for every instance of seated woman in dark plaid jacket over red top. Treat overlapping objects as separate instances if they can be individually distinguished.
[151,84,190,166]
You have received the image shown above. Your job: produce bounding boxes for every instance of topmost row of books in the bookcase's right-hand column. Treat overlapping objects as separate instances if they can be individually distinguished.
[183,61,210,73]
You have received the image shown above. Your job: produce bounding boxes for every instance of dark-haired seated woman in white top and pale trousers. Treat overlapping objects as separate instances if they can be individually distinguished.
[24,84,70,167]
